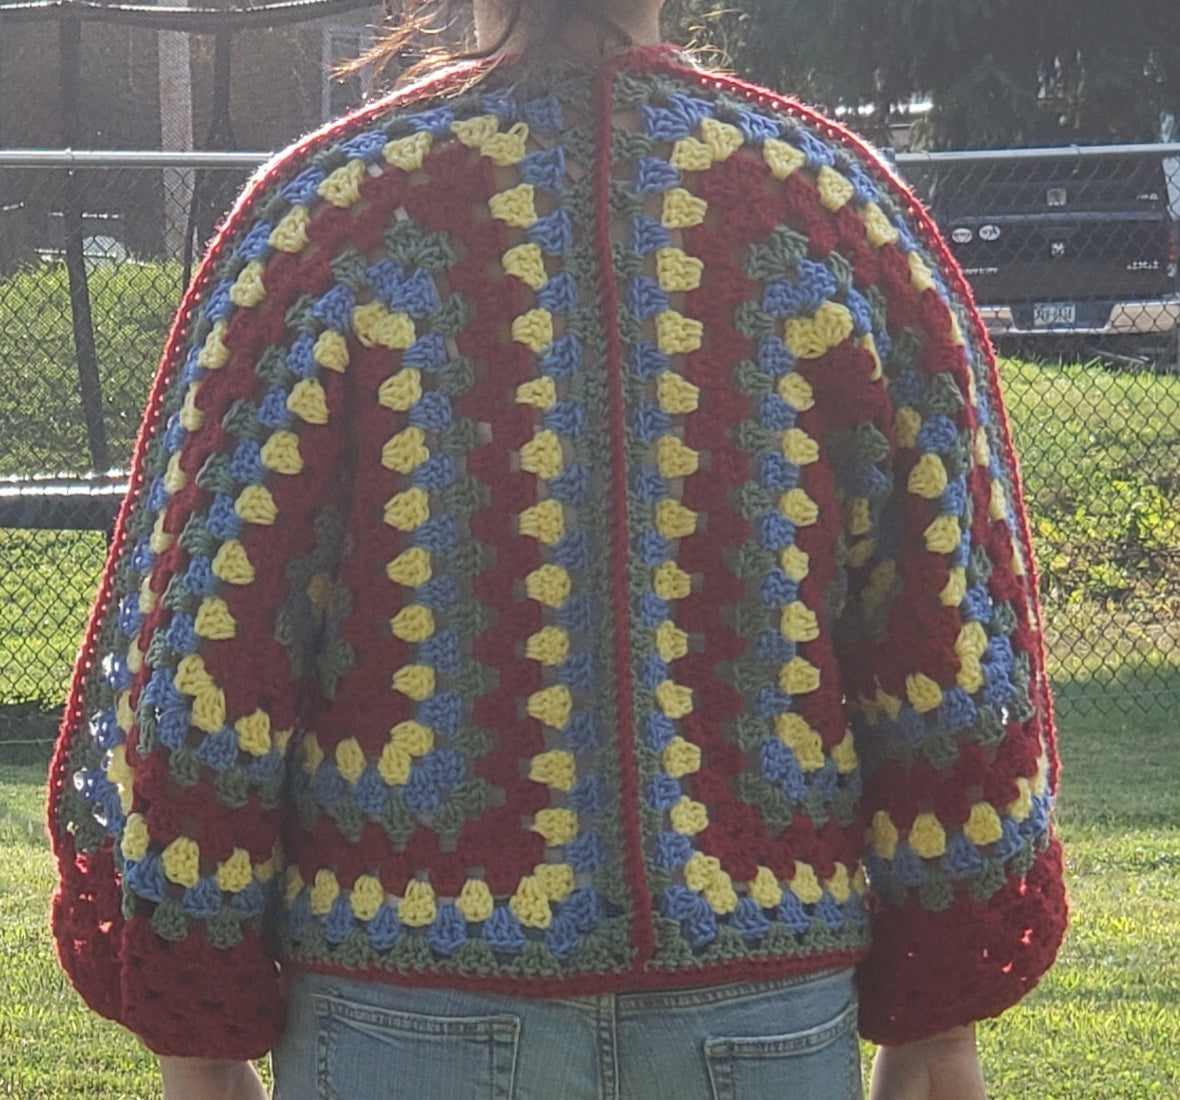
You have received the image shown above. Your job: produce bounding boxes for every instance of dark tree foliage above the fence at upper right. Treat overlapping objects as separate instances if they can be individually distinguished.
[668,0,1180,148]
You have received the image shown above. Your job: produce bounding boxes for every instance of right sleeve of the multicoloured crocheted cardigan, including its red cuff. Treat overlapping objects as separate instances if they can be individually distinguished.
[841,201,1066,1043]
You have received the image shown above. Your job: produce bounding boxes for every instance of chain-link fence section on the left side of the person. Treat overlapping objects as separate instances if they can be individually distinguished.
[0,151,263,764]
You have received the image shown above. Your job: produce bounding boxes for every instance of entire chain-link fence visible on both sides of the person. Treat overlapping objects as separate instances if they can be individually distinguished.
[0,145,1180,764]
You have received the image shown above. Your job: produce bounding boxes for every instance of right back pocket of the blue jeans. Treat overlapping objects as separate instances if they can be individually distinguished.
[704,1001,864,1100]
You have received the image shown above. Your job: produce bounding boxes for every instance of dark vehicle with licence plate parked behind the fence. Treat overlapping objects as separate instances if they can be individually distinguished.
[898,146,1180,345]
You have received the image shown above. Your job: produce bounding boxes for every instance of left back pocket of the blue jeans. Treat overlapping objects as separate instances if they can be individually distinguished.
[312,994,520,1100]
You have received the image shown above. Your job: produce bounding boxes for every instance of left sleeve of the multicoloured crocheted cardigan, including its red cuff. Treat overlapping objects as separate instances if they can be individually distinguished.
[50,148,347,1059]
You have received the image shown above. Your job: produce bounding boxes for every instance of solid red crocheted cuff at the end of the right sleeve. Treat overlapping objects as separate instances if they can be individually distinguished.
[858,840,1067,1046]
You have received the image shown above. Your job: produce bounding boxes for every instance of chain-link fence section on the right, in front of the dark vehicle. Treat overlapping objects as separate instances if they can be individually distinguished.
[900,144,1180,726]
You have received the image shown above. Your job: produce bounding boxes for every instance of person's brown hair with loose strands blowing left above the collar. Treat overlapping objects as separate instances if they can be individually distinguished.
[340,0,631,84]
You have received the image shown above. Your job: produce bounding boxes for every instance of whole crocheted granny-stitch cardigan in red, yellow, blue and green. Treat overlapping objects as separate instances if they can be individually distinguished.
[50,51,1064,1058]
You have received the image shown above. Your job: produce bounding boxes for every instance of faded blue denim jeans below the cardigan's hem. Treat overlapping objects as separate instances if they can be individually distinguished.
[273,970,863,1100]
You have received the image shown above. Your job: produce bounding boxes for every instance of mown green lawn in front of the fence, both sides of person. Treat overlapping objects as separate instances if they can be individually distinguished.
[0,693,1180,1100]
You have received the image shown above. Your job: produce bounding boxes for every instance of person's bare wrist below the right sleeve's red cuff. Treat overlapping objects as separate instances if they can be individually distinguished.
[868,1023,988,1100]
